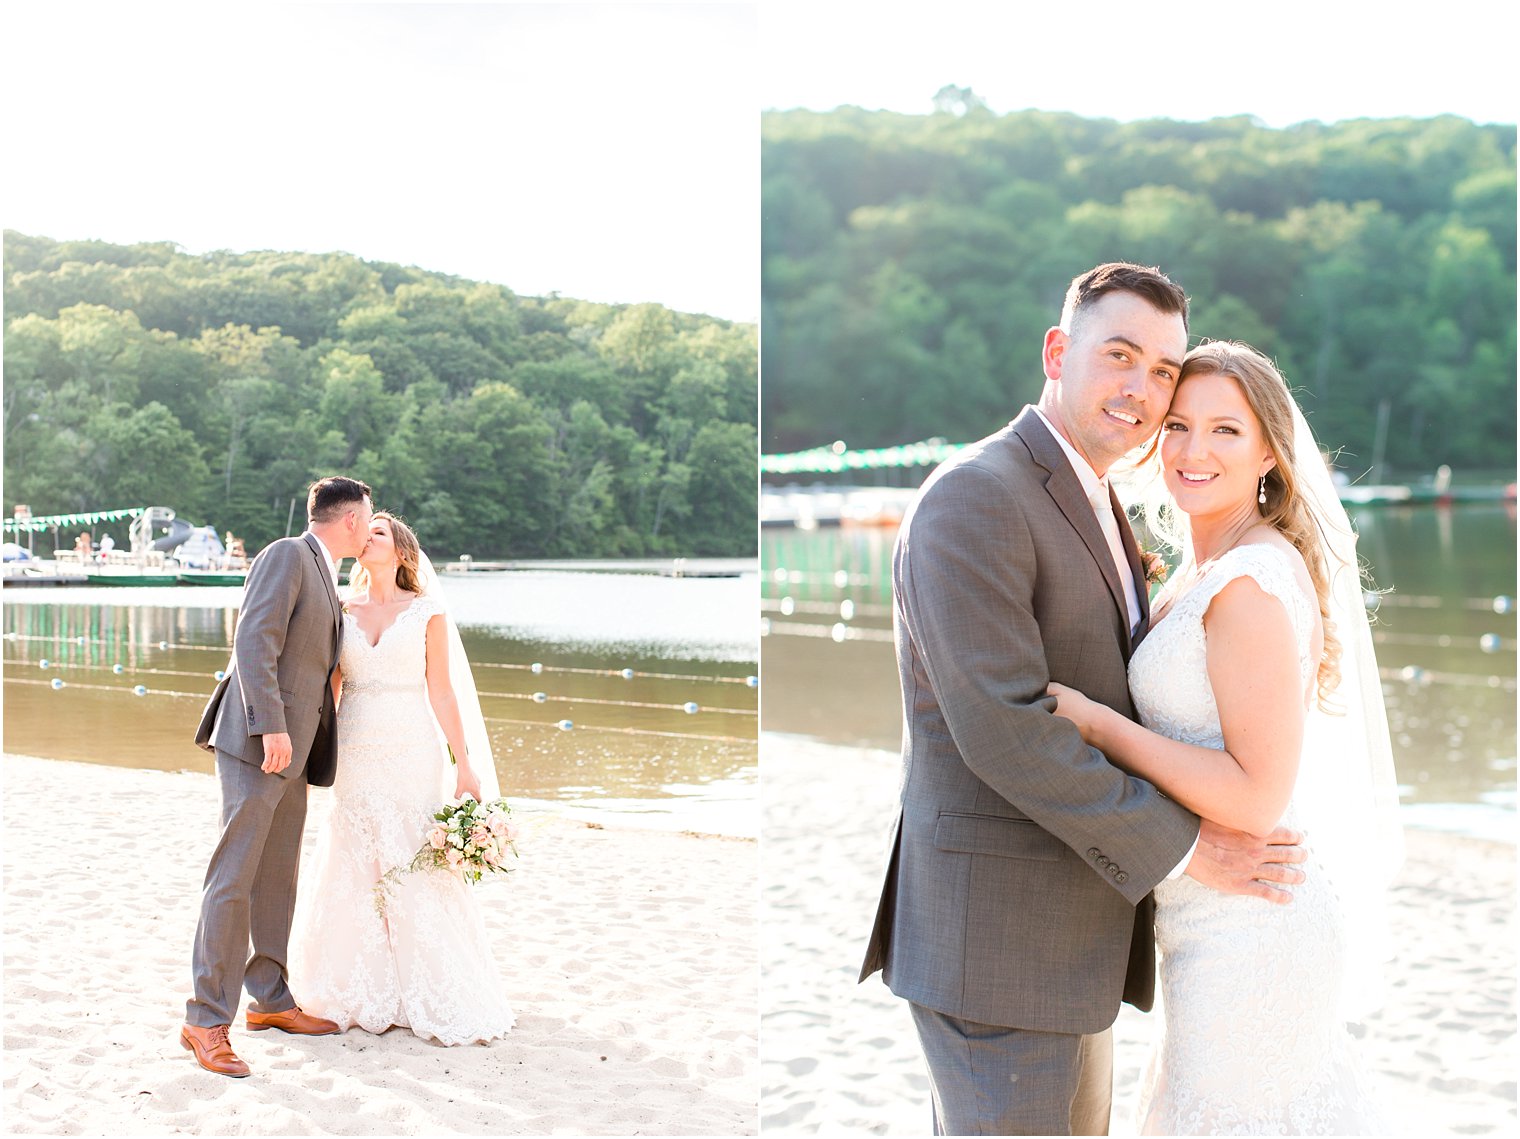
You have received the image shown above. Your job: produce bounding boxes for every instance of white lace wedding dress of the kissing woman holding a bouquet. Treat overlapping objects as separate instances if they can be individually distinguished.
[290,595,512,1045]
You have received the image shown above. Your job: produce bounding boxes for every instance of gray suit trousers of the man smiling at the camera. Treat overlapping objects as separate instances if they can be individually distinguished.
[909,1002,1114,1134]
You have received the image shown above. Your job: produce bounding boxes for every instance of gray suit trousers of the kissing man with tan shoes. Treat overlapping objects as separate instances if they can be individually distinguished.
[185,750,307,1028]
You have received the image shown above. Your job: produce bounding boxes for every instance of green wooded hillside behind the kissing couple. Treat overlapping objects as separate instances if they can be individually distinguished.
[5,231,757,558]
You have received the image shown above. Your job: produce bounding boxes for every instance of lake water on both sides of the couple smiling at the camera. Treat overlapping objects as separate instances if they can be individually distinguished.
[760,503,1515,841]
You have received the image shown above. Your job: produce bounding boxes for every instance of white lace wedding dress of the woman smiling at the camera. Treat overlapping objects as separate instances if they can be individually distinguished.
[1129,544,1392,1134]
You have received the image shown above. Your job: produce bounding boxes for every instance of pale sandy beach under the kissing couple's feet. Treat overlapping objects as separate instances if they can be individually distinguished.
[3,756,758,1136]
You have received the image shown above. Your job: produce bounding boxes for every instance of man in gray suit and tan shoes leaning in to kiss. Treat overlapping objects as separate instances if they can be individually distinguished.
[179,477,372,1077]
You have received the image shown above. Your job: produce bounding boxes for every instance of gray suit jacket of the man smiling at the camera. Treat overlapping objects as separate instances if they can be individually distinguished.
[860,408,1198,1033]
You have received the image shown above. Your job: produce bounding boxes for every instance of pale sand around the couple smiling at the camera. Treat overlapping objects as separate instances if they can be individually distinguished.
[760,734,1517,1136]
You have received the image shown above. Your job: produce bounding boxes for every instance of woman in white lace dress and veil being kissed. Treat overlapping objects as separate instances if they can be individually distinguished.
[290,511,512,1045]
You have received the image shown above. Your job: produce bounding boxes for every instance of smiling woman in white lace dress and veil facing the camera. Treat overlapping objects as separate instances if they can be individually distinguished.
[1050,342,1400,1134]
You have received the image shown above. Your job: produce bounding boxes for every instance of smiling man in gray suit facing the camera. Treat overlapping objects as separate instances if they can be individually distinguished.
[860,263,1304,1134]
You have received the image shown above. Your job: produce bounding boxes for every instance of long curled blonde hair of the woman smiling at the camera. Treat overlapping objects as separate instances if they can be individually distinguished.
[1145,341,1357,707]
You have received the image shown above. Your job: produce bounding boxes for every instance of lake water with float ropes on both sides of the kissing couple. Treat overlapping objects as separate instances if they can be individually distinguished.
[3,572,758,835]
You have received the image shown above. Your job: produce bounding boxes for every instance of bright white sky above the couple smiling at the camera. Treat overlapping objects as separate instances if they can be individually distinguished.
[760,0,1520,126]
